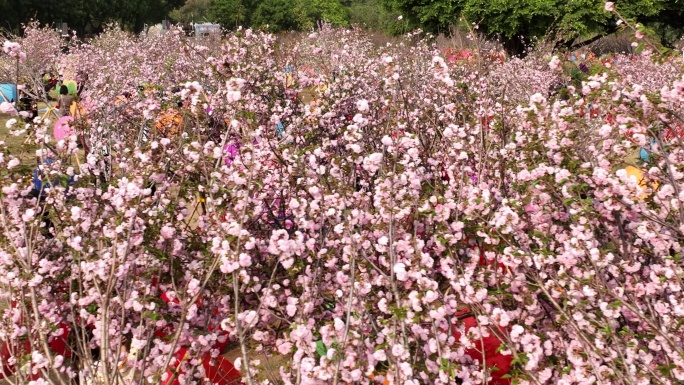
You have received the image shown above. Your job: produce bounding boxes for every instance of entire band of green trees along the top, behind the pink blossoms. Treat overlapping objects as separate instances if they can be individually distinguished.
[0,0,684,53]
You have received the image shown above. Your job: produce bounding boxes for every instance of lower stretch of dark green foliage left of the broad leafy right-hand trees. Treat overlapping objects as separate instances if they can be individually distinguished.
[0,0,398,35]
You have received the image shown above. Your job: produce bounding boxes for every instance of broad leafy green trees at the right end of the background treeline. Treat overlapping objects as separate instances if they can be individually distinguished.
[384,0,684,55]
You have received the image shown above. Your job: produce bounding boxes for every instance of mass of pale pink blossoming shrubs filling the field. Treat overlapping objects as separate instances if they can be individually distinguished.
[0,20,684,384]
